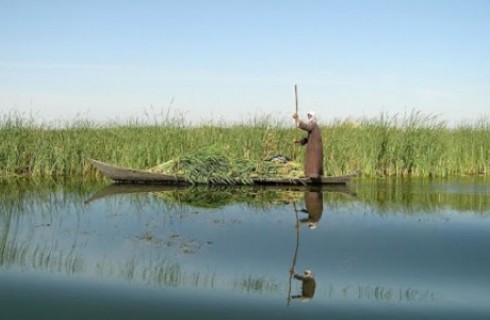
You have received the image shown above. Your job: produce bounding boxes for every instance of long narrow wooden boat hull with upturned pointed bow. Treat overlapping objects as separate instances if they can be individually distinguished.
[85,158,357,185]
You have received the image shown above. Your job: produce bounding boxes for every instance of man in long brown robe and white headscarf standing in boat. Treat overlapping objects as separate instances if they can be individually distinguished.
[293,111,323,179]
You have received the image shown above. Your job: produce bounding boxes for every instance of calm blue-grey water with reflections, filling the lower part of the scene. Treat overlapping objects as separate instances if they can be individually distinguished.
[0,178,490,319]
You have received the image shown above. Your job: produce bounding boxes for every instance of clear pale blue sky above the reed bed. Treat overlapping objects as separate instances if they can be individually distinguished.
[0,0,490,123]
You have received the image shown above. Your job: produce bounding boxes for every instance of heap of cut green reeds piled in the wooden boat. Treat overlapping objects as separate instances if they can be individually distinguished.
[150,146,303,185]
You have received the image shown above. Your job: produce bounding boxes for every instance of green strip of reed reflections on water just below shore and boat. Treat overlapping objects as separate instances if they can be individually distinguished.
[0,178,490,215]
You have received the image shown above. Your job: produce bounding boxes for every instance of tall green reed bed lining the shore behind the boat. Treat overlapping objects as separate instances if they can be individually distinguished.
[0,111,490,179]
